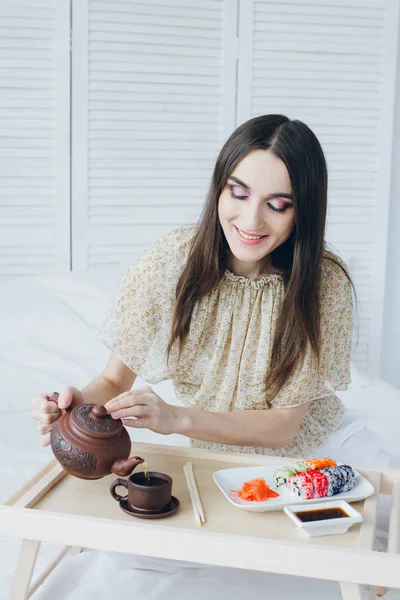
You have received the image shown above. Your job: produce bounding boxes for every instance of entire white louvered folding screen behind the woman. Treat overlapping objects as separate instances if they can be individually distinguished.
[0,0,399,374]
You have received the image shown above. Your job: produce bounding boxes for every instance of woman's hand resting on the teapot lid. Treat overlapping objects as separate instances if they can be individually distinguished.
[104,385,179,435]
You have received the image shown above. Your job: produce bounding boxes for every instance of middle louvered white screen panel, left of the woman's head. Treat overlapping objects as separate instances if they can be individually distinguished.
[72,0,236,269]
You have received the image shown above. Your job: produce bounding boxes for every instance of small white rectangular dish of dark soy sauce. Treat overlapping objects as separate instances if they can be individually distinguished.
[283,500,363,537]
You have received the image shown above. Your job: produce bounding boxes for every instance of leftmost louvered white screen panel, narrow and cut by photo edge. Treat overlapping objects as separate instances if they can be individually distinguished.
[0,0,70,276]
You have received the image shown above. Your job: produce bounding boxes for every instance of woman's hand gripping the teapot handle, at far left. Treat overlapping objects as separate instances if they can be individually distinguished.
[31,386,84,446]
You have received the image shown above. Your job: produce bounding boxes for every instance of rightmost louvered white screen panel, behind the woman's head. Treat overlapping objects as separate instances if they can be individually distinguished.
[238,0,398,374]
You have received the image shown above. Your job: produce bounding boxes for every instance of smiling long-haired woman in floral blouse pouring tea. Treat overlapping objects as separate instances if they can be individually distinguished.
[32,115,394,540]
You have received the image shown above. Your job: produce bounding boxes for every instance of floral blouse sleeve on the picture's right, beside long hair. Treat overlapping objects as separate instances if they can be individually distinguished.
[271,255,353,408]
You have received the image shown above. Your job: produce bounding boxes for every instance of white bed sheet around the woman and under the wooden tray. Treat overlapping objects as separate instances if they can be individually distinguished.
[0,272,400,600]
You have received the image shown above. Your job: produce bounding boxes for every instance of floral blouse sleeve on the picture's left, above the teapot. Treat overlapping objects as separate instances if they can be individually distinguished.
[98,226,196,384]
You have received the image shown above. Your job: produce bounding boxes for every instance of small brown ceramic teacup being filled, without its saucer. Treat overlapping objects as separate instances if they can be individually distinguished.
[110,471,172,513]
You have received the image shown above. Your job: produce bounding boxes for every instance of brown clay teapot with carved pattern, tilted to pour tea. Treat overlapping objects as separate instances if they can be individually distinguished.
[50,392,144,479]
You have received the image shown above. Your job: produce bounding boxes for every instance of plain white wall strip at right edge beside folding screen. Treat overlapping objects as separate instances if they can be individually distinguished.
[381,10,400,390]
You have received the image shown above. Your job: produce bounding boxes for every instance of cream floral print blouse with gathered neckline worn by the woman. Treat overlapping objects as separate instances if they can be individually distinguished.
[99,225,353,457]
